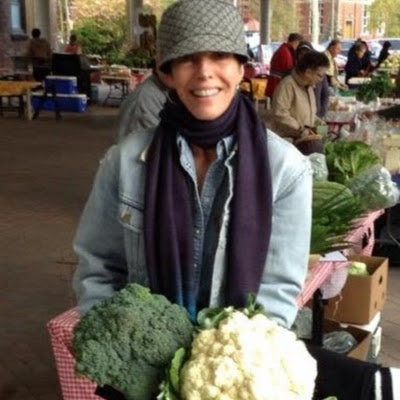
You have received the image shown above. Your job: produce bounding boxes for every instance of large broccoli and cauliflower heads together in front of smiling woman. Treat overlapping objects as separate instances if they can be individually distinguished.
[73,284,334,400]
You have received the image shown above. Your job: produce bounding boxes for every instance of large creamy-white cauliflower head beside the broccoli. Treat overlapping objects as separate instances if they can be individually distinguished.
[181,311,317,400]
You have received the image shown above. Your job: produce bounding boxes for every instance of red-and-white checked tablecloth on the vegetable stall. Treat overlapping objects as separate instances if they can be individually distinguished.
[47,210,383,400]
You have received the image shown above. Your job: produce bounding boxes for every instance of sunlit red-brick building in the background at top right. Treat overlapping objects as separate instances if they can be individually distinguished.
[296,0,373,41]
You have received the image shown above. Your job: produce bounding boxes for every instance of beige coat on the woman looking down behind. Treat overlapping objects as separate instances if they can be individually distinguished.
[267,71,317,138]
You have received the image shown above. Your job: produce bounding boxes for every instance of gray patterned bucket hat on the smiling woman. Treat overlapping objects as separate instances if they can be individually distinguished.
[158,0,248,72]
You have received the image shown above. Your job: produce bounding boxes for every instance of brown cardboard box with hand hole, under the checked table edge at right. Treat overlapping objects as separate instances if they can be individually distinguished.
[325,255,388,325]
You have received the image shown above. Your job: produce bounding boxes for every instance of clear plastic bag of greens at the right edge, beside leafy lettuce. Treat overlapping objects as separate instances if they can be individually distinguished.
[346,164,400,211]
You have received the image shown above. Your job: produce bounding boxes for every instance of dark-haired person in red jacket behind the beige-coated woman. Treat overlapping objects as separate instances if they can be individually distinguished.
[265,33,303,97]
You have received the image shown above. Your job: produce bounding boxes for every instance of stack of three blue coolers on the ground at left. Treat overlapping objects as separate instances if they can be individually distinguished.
[32,75,87,112]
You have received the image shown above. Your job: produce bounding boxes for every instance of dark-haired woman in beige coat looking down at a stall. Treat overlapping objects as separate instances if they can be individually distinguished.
[269,50,329,142]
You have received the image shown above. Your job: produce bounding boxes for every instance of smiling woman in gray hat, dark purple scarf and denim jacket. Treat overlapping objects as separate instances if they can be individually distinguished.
[74,0,398,400]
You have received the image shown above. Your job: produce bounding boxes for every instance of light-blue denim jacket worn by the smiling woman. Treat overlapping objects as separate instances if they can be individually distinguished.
[73,130,312,327]
